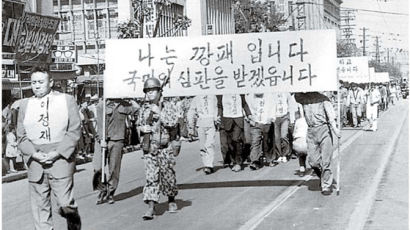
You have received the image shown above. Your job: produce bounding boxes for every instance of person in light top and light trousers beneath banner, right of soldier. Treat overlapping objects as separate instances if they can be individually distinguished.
[187,95,220,174]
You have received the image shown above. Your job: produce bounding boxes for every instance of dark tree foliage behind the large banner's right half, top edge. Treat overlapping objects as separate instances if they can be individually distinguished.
[234,0,286,33]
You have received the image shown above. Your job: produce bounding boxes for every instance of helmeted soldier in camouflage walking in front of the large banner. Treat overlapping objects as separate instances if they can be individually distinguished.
[137,78,181,220]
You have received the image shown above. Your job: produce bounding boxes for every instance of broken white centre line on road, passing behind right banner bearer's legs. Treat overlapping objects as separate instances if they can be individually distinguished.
[239,127,363,230]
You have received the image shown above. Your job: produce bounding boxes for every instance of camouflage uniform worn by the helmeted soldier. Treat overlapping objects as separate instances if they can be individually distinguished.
[138,102,180,203]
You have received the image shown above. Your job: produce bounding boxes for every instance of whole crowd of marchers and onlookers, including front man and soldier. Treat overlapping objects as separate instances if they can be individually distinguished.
[3,64,406,229]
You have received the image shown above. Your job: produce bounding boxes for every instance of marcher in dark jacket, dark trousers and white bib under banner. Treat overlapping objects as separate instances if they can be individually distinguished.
[217,94,251,172]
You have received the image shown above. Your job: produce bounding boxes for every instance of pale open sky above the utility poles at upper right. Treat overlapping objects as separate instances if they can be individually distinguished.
[341,0,409,51]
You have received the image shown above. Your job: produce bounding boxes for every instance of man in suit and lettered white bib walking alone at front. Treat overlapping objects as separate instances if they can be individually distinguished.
[17,67,81,230]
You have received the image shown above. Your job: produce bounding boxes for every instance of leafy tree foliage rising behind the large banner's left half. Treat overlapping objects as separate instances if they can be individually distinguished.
[118,0,191,38]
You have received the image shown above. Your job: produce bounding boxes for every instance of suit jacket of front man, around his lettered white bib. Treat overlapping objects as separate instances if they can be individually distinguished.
[17,92,81,182]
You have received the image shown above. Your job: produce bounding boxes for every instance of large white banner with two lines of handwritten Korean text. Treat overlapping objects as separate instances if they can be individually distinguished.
[104,30,337,98]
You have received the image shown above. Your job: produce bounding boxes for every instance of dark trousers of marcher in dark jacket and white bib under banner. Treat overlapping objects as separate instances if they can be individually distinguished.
[220,122,244,165]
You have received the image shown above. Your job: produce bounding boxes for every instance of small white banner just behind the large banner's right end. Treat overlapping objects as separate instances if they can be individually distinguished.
[337,57,370,83]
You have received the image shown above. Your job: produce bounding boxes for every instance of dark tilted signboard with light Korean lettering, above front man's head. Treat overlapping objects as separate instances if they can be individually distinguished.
[15,12,60,63]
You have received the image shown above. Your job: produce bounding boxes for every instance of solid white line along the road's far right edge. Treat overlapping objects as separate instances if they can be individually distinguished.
[346,104,407,230]
